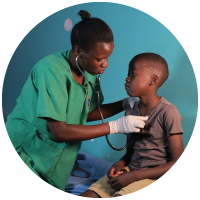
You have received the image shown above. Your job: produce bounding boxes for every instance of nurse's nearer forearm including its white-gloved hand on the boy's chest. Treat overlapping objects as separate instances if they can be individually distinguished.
[44,115,147,142]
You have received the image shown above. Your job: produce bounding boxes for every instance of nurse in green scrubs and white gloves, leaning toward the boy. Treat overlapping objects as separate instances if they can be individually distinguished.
[5,11,146,191]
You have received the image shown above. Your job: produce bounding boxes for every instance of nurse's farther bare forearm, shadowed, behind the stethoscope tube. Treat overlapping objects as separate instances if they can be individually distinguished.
[87,100,124,122]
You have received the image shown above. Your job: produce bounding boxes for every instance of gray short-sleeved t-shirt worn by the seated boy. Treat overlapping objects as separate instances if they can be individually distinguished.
[125,97,183,171]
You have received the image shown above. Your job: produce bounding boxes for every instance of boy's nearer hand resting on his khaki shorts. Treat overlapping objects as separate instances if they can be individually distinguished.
[108,172,134,191]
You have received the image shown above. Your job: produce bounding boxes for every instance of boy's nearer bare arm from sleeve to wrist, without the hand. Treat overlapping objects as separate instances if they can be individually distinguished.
[130,134,184,181]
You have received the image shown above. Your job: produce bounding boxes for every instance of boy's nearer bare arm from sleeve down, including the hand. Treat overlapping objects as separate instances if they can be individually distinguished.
[109,134,184,190]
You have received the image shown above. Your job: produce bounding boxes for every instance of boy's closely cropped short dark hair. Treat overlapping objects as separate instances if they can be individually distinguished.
[130,52,169,87]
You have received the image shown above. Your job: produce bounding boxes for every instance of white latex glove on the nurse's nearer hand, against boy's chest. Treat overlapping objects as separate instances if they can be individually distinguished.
[109,115,148,135]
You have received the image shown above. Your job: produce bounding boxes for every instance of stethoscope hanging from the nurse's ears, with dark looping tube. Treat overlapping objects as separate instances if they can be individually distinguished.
[75,53,131,151]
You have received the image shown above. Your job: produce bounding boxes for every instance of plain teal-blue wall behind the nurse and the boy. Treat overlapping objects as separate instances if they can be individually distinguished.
[2,2,198,162]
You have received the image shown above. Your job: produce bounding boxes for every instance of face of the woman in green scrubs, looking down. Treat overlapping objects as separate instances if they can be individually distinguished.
[78,42,114,76]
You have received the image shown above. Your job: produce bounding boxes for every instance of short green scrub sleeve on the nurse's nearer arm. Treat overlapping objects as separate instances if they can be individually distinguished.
[34,66,68,121]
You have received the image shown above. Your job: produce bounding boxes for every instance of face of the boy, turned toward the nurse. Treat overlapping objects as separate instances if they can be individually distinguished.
[125,59,151,97]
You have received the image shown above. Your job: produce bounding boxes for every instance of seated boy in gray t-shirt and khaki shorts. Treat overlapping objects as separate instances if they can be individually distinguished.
[79,53,184,198]
